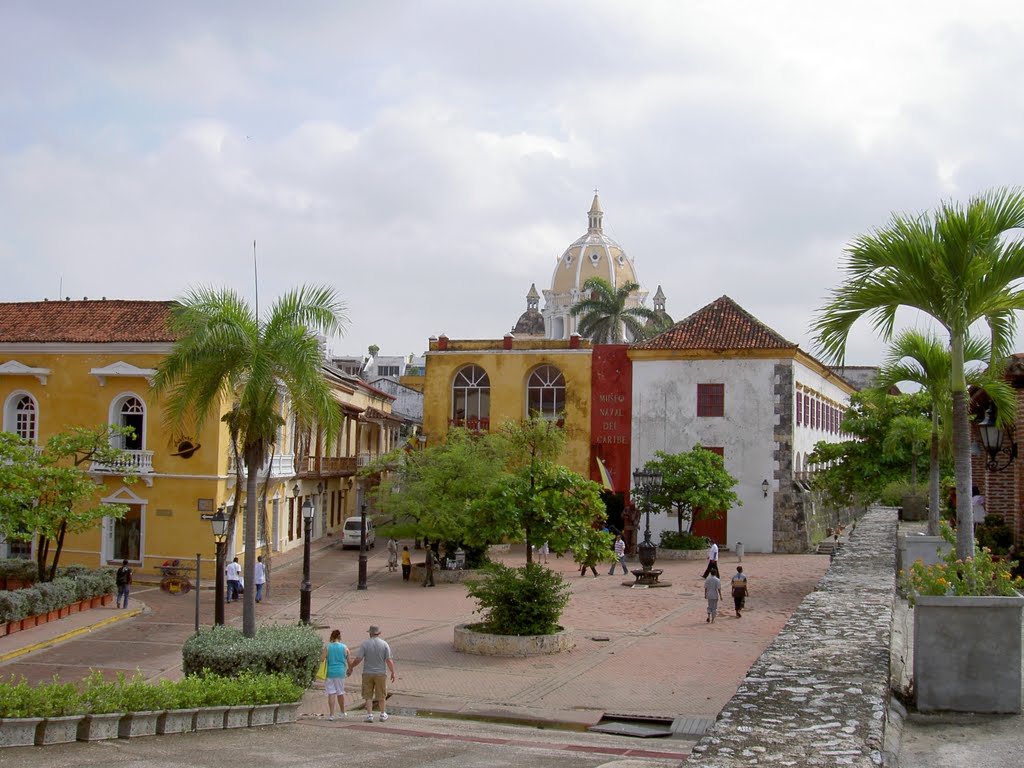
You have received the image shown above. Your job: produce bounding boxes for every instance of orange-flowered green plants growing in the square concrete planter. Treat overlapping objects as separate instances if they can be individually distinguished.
[899,522,1024,605]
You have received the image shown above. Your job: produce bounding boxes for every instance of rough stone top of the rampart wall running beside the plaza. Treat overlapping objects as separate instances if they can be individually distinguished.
[686,509,896,768]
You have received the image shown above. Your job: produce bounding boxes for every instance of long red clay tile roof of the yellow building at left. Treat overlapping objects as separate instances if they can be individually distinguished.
[0,299,174,344]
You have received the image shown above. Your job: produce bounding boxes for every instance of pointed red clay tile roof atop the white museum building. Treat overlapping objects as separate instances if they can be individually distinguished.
[633,296,798,349]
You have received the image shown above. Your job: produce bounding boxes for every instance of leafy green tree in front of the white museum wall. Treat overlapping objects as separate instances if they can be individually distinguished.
[641,445,742,534]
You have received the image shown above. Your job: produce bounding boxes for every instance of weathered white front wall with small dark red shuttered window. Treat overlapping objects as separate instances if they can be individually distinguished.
[632,358,778,552]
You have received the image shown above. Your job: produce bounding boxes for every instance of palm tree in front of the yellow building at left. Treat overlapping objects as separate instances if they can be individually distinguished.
[154,287,348,637]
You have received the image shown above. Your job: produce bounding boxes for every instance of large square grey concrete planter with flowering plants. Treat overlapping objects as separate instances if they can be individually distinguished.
[901,523,1024,714]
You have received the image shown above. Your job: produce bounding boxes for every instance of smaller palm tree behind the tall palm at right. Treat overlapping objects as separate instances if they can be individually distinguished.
[876,330,1006,536]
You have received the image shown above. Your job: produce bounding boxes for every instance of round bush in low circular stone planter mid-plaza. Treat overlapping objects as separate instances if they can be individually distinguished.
[455,563,572,656]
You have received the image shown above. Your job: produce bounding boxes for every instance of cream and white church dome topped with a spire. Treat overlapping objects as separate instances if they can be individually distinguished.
[546,193,639,295]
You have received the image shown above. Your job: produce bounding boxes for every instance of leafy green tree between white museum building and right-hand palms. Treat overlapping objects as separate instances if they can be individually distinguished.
[807,389,929,507]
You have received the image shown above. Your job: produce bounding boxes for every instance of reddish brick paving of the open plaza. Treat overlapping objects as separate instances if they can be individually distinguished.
[0,547,828,736]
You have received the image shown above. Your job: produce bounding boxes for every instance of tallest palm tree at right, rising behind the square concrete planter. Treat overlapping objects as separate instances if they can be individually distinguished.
[811,187,1024,558]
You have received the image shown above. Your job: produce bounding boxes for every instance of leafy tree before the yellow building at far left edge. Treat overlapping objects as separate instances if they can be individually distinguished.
[0,426,134,582]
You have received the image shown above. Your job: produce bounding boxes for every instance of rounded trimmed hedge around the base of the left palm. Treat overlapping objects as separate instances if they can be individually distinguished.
[181,625,324,689]
